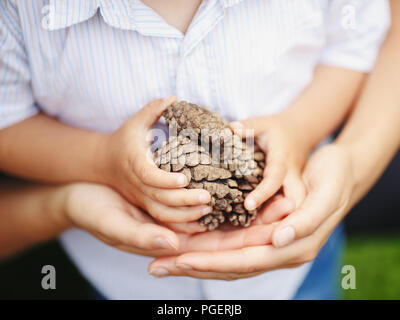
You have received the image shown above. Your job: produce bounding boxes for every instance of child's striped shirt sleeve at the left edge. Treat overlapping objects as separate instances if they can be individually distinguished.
[0,0,38,130]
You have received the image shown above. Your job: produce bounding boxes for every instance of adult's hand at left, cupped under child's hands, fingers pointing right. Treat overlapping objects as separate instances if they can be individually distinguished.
[62,183,273,258]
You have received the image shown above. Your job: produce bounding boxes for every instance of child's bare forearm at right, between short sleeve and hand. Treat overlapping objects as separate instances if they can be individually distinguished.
[282,65,366,154]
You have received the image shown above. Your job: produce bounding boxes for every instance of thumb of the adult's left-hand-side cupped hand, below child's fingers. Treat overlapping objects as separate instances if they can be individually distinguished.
[91,208,179,250]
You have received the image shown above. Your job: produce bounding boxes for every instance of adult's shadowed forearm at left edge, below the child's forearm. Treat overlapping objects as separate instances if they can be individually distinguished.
[0,179,69,259]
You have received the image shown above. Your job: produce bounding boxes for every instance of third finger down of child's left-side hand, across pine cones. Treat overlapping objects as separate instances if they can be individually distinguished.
[146,198,212,223]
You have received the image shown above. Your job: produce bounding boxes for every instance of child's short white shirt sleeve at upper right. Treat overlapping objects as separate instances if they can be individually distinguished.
[320,0,390,72]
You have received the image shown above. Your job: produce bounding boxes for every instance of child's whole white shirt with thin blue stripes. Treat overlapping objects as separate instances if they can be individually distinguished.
[0,0,390,299]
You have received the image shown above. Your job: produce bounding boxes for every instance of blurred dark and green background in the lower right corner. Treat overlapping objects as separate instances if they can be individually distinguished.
[343,153,400,299]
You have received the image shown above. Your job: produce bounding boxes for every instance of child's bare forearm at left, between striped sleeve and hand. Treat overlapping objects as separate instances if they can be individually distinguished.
[0,114,108,183]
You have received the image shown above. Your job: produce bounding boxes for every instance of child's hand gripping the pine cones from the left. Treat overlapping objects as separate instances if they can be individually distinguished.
[100,96,211,232]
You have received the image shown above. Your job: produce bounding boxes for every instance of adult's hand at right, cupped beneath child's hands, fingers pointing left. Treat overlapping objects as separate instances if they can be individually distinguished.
[149,144,354,280]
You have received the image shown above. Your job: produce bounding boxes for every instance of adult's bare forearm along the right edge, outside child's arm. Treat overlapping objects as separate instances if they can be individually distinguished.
[336,8,400,208]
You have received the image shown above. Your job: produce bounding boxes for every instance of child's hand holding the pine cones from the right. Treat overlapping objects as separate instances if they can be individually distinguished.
[231,115,309,223]
